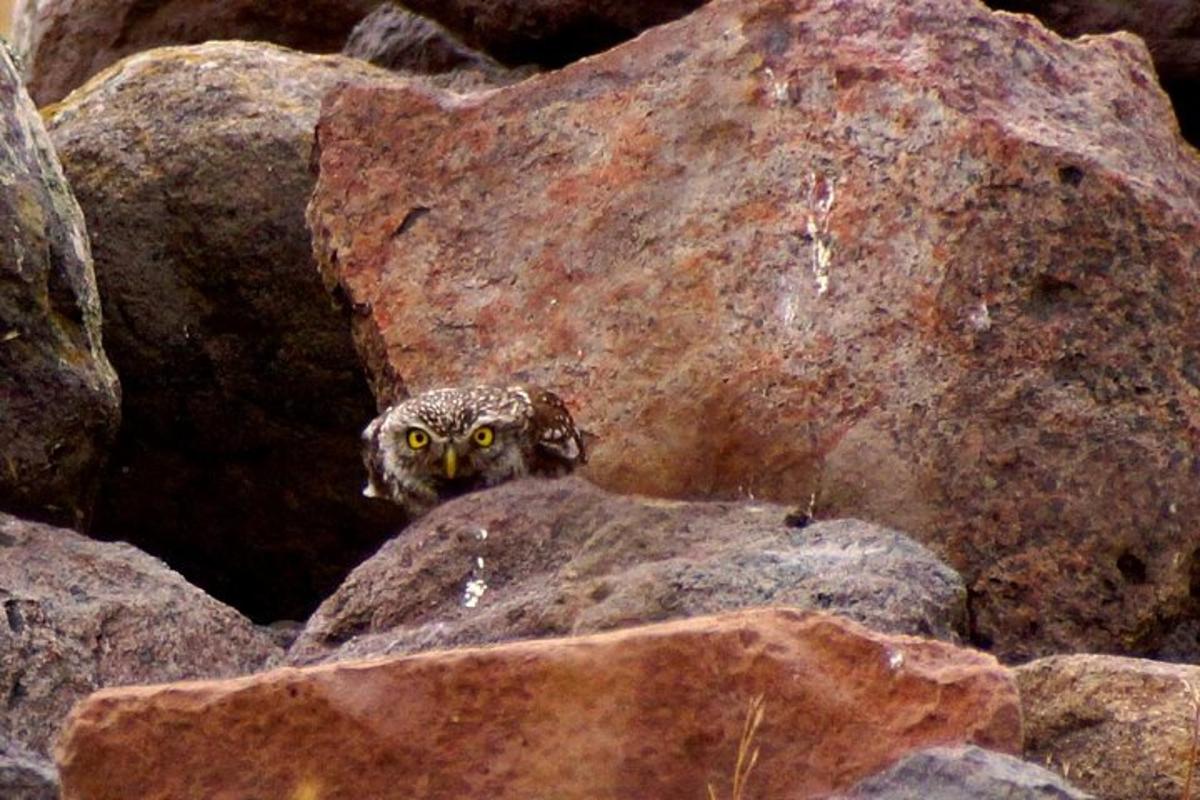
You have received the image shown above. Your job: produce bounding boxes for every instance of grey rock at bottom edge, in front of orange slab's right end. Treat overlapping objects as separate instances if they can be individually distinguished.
[845,745,1092,800]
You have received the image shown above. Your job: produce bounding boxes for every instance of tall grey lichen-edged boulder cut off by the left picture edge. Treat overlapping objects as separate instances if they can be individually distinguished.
[0,46,120,527]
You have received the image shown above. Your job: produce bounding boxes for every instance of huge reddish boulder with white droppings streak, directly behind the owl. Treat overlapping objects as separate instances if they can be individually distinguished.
[310,0,1200,658]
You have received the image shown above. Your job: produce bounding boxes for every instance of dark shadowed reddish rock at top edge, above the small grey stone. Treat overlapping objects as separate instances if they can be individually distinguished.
[388,0,706,67]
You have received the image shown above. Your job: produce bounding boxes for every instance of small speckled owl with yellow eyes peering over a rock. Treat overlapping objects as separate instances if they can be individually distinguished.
[362,386,587,517]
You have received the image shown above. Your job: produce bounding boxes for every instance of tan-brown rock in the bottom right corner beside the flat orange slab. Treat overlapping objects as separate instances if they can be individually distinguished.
[1015,655,1200,800]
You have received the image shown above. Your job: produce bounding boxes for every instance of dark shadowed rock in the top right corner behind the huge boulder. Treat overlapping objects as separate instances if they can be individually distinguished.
[986,0,1200,146]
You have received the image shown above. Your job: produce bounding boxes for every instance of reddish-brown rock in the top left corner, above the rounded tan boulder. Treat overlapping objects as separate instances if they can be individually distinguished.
[12,0,379,106]
